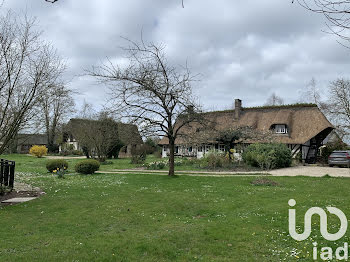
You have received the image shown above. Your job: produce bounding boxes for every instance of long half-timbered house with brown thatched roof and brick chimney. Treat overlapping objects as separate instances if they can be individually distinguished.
[160,99,334,161]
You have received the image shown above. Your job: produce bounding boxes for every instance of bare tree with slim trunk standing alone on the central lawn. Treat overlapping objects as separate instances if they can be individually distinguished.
[89,40,198,176]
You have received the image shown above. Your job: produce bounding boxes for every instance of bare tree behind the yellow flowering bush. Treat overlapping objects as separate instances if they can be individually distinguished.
[39,83,75,151]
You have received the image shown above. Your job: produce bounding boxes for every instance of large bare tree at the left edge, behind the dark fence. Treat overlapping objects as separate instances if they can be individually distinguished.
[0,12,65,154]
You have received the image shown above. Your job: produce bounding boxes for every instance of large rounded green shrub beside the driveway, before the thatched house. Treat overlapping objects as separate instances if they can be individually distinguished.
[242,143,292,169]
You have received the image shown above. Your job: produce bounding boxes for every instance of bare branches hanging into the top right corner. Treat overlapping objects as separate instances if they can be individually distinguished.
[292,0,350,44]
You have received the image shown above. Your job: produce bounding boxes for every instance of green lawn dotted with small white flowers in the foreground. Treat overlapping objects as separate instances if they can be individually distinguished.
[0,155,350,261]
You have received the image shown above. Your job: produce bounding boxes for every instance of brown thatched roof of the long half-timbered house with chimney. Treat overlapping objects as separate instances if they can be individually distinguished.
[159,104,333,145]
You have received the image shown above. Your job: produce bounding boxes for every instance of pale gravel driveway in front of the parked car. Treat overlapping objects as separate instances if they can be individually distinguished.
[268,166,350,177]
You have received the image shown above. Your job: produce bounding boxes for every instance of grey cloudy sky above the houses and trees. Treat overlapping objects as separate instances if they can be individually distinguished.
[3,0,350,109]
